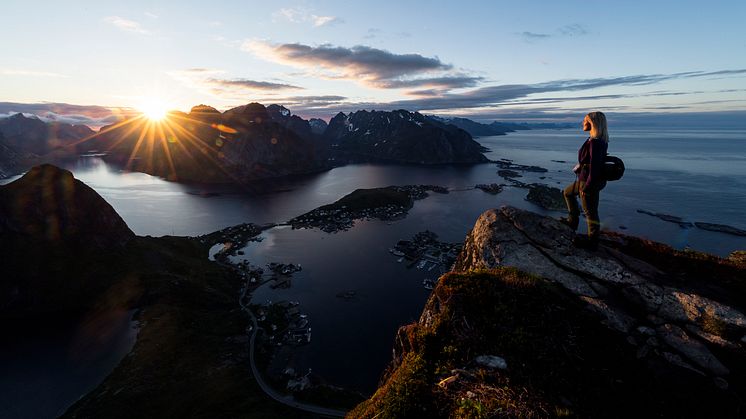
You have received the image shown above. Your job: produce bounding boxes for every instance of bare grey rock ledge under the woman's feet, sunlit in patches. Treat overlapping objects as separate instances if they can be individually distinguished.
[456,207,746,376]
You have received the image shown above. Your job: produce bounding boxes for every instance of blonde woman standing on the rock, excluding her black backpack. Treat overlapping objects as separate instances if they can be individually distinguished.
[562,112,609,249]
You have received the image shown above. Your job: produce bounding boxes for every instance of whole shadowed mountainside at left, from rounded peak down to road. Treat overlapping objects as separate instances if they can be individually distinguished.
[0,165,307,418]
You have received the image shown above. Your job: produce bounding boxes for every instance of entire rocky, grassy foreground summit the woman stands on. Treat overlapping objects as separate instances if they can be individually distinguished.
[349,207,746,418]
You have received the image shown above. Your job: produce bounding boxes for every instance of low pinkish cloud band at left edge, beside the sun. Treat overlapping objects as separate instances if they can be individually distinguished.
[0,102,134,129]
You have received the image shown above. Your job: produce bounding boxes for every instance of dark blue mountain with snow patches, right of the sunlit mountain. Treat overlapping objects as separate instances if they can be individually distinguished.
[324,110,487,164]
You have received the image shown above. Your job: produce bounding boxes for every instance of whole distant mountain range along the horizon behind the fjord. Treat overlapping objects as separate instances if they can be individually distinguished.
[0,103,566,183]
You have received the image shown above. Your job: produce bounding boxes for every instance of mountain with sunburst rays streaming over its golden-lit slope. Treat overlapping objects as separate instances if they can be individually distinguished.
[94,103,327,183]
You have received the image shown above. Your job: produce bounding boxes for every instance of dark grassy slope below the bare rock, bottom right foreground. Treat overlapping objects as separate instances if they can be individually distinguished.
[349,268,743,418]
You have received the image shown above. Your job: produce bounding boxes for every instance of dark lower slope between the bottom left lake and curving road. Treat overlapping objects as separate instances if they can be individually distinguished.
[65,237,302,418]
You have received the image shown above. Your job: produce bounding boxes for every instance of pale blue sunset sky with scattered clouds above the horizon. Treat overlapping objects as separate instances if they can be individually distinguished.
[0,0,746,125]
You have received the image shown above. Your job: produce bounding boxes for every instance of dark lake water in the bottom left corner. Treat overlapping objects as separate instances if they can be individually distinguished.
[0,310,138,419]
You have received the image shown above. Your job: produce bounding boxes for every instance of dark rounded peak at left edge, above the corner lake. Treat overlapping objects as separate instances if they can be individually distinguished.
[0,165,134,318]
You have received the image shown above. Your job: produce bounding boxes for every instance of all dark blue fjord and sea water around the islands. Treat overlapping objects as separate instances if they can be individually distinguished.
[2,129,746,404]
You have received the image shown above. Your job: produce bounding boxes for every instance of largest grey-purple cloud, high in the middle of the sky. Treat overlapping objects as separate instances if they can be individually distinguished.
[242,40,476,91]
